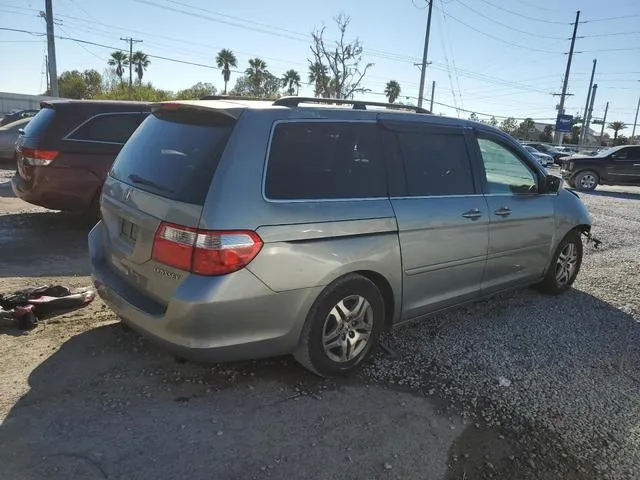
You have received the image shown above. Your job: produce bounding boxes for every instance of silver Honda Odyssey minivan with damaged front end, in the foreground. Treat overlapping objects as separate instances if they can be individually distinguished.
[89,97,590,376]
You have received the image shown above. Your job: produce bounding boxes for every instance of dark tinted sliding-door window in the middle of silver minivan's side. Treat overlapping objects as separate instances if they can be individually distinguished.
[398,130,475,196]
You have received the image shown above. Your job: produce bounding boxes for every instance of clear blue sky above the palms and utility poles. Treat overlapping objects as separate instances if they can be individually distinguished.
[0,0,640,135]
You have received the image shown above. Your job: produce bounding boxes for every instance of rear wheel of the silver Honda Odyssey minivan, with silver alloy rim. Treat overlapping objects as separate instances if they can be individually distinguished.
[294,274,385,377]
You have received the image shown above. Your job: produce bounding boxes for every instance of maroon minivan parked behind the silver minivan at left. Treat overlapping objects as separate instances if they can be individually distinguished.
[11,100,149,215]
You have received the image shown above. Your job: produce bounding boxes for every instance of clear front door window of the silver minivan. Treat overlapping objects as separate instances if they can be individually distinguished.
[478,138,538,193]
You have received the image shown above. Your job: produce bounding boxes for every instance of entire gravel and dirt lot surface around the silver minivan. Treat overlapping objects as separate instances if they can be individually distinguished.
[0,164,640,480]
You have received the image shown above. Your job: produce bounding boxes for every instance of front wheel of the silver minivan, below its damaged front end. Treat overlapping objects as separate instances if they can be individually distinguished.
[538,230,582,295]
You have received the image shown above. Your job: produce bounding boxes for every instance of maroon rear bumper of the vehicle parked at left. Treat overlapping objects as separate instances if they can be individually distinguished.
[11,166,102,212]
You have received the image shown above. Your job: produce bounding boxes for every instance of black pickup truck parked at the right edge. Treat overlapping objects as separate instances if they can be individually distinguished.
[561,145,640,192]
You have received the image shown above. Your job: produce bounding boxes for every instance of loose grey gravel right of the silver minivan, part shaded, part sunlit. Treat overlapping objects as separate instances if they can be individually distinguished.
[365,182,640,479]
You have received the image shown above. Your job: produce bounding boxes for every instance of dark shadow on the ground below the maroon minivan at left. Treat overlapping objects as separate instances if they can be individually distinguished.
[0,212,95,278]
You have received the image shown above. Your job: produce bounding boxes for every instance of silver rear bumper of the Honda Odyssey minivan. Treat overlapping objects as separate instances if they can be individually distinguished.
[89,222,322,361]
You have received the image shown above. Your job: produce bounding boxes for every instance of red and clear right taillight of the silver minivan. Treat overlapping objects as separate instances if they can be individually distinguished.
[152,222,262,275]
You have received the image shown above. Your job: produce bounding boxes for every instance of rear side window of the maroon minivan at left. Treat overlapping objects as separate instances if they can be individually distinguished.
[69,113,144,144]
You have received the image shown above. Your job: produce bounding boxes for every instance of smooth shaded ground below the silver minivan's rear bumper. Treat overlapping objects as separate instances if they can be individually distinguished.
[0,324,464,480]
